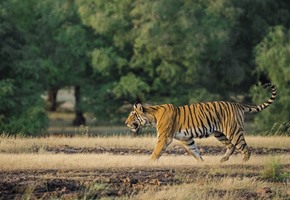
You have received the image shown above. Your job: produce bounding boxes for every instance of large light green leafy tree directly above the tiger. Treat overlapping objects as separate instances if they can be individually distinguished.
[77,0,243,124]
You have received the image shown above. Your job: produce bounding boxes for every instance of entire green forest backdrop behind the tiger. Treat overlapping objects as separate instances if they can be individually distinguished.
[0,0,290,135]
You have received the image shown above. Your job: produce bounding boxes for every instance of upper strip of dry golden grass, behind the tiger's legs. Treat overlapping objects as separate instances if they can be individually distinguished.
[0,136,290,153]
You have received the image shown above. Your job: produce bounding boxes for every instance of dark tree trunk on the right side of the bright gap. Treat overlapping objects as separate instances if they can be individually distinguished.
[73,85,86,126]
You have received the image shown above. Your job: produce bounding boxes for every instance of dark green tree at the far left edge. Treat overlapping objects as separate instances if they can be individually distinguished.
[0,0,48,135]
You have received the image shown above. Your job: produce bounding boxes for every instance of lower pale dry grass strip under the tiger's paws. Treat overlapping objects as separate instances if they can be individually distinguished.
[0,152,290,170]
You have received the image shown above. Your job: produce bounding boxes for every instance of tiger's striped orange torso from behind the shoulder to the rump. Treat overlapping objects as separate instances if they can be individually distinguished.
[174,101,244,138]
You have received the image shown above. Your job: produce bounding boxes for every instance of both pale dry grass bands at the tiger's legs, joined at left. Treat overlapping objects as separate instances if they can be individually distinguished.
[0,136,290,170]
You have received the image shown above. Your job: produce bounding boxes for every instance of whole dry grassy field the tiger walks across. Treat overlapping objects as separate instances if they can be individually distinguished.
[0,136,290,199]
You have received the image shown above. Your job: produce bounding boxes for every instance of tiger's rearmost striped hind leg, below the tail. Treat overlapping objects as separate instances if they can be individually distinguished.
[232,129,251,161]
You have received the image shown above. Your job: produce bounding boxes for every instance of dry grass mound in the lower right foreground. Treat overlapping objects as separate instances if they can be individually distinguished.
[125,177,287,200]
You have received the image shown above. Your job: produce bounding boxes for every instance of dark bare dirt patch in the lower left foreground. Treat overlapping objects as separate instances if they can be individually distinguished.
[0,169,251,199]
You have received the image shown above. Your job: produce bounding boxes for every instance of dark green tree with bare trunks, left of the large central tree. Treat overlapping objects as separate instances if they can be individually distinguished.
[32,0,93,125]
